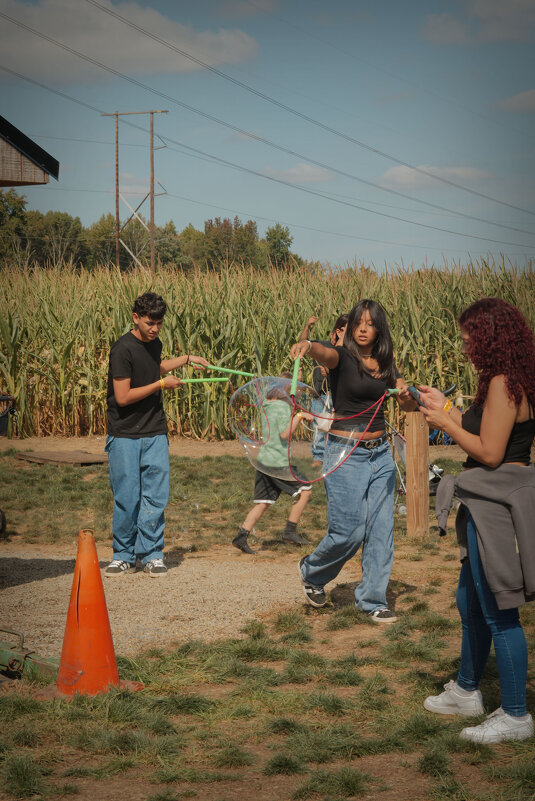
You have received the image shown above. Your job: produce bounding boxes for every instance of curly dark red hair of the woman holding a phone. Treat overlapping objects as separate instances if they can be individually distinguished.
[459,298,535,406]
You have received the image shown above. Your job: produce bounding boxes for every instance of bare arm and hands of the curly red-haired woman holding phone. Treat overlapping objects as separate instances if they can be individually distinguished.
[421,375,517,467]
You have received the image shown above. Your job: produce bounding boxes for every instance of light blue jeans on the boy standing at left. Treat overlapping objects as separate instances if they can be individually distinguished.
[105,434,169,564]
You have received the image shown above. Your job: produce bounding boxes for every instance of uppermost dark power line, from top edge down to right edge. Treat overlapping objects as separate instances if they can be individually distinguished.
[86,0,535,215]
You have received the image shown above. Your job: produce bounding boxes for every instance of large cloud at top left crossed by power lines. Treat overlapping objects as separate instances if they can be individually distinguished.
[0,0,257,85]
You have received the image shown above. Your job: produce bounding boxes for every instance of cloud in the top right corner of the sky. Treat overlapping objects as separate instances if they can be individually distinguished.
[421,0,535,45]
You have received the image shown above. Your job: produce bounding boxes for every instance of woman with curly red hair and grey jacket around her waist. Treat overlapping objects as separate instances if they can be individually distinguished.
[420,298,535,743]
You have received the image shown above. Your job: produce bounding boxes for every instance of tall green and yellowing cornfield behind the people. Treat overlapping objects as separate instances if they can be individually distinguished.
[0,262,535,438]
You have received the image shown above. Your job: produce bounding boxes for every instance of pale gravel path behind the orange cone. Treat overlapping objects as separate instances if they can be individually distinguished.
[0,542,314,656]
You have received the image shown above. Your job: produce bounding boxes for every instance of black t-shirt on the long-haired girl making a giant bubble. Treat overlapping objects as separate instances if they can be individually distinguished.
[329,346,399,431]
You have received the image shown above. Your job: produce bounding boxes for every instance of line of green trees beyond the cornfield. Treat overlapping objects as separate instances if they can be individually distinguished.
[0,189,304,270]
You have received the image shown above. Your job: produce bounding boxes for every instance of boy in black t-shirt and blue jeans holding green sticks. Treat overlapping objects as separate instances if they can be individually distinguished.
[104,292,208,577]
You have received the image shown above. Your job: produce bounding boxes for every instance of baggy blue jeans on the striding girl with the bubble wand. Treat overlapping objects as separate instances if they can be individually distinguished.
[301,434,396,612]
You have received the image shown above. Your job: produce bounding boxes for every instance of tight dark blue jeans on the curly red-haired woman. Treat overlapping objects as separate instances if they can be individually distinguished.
[457,514,528,717]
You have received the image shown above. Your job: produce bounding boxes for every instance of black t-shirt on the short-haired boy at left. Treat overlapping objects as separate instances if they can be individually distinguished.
[108,331,167,439]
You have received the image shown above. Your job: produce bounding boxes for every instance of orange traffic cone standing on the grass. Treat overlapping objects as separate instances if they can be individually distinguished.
[57,530,143,695]
